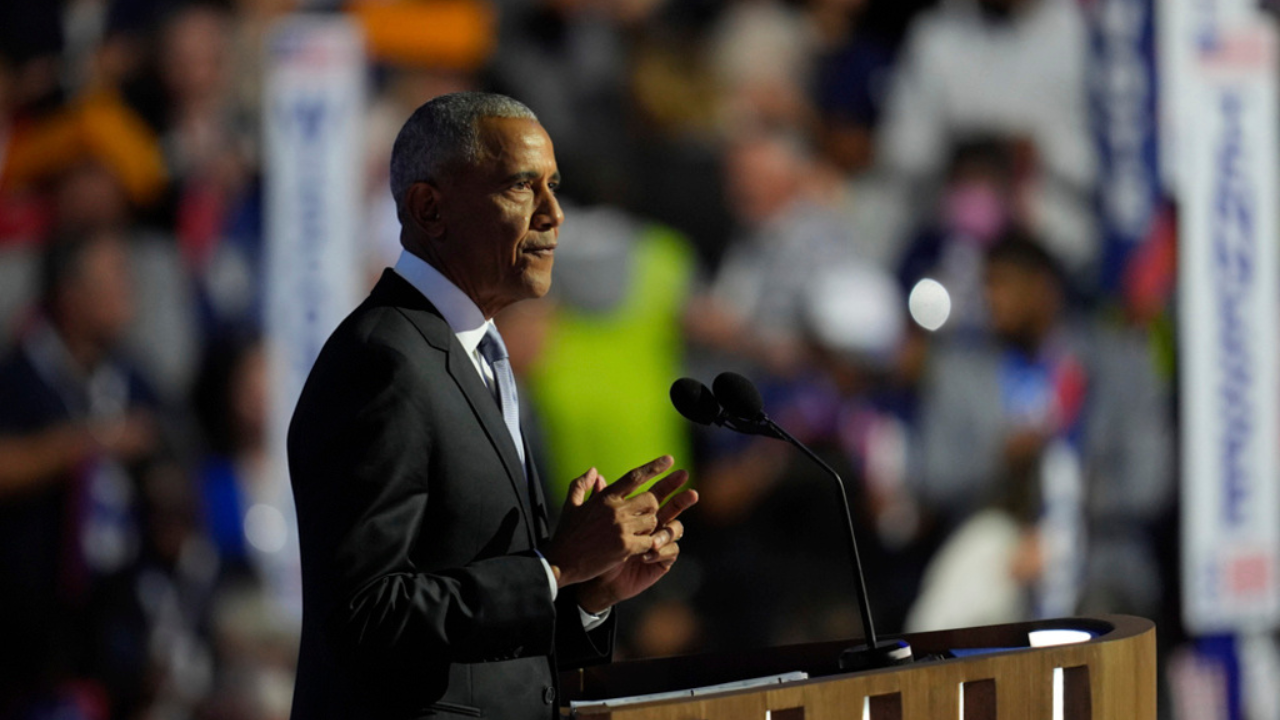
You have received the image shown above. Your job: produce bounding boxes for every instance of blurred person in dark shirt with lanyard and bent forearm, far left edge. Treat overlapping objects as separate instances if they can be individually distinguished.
[0,229,159,717]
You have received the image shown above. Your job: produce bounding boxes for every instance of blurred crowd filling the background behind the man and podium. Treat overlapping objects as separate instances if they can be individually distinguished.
[0,0,1179,720]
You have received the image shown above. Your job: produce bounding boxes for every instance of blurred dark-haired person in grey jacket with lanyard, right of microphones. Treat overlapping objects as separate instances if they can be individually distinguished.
[913,231,1172,629]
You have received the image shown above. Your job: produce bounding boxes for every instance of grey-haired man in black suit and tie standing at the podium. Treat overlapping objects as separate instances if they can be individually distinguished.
[289,92,698,720]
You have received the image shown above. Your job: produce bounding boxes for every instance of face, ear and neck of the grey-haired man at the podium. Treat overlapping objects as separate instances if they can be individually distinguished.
[430,118,564,318]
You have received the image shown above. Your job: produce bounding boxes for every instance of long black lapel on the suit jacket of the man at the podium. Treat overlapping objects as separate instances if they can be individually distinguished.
[370,269,545,547]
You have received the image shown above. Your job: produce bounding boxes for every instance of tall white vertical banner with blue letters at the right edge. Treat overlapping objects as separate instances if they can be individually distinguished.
[1164,0,1280,634]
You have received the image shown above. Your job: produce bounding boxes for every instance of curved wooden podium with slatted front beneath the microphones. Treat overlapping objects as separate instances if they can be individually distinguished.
[561,615,1156,720]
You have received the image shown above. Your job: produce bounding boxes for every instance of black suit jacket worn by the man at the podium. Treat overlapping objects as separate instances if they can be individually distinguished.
[288,270,613,720]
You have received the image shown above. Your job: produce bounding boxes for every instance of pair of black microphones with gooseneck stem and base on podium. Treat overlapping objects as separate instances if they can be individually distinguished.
[671,373,913,670]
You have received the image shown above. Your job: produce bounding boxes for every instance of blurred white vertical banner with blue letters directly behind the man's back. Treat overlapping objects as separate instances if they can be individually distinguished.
[262,15,366,615]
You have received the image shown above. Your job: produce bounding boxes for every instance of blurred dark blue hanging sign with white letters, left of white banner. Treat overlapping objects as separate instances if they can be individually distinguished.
[1085,0,1161,290]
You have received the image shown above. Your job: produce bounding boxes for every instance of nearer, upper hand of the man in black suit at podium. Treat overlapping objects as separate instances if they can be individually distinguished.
[543,455,689,587]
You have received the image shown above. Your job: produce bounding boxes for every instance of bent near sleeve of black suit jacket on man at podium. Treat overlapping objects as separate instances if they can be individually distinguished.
[289,326,556,673]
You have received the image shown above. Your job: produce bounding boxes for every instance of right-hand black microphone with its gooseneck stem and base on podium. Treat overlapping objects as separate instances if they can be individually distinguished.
[701,373,911,670]
